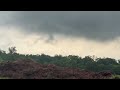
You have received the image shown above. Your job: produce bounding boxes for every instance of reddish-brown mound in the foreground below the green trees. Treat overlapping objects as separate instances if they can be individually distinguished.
[0,60,112,79]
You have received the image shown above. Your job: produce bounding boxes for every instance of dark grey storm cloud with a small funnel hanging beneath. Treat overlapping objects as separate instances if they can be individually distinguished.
[1,11,120,41]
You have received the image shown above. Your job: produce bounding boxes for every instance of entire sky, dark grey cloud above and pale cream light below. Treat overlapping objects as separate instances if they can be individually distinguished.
[0,11,120,59]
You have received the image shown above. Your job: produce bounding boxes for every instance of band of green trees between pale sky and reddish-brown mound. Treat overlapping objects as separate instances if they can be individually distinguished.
[0,47,120,74]
